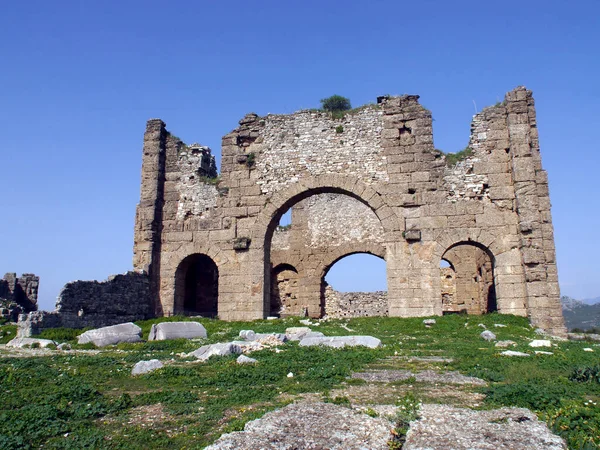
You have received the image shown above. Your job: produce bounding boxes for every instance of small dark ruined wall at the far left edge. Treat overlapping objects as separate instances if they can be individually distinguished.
[0,273,40,322]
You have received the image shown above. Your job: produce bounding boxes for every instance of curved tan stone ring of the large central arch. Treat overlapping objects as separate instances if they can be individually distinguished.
[252,175,404,317]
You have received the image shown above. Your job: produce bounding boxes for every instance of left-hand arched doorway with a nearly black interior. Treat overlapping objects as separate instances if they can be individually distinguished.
[175,254,219,317]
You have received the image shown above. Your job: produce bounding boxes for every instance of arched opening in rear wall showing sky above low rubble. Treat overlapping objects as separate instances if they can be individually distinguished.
[321,253,388,317]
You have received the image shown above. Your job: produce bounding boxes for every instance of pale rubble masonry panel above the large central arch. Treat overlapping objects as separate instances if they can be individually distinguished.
[248,105,389,194]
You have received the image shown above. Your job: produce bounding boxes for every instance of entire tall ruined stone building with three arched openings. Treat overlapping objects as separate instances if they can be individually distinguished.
[134,87,565,334]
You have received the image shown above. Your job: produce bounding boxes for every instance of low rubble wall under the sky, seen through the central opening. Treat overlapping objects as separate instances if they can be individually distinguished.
[324,285,388,319]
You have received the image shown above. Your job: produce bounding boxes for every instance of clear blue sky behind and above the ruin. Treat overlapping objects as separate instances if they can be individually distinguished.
[0,0,600,309]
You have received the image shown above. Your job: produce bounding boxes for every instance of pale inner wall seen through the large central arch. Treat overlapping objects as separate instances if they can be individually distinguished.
[263,186,394,317]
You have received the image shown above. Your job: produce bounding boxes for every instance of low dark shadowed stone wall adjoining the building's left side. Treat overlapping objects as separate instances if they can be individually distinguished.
[19,272,153,336]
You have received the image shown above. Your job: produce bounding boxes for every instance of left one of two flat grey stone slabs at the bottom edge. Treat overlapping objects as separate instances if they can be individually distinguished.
[206,402,390,450]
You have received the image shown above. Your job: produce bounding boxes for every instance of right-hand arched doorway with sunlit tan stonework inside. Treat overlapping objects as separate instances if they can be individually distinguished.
[440,241,498,314]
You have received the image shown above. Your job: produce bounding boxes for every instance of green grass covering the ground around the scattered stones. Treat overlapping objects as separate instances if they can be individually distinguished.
[0,314,600,449]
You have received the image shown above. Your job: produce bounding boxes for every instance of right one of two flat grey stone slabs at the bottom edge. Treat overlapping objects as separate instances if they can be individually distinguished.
[402,405,567,450]
